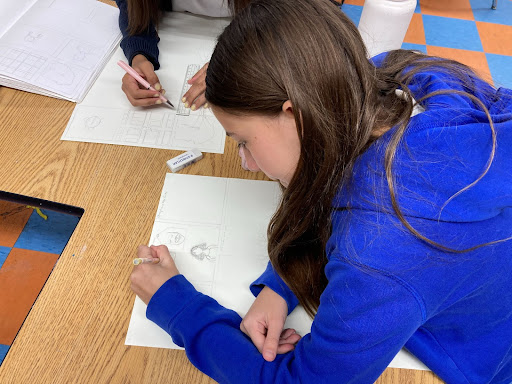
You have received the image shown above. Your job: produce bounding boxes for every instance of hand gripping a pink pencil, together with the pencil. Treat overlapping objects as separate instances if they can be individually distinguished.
[117,55,174,107]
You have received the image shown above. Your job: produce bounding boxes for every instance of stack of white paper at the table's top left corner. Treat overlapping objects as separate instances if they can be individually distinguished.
[0,0,121,102]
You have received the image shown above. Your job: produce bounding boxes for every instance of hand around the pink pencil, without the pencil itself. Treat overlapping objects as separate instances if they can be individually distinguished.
[121,55,165,107]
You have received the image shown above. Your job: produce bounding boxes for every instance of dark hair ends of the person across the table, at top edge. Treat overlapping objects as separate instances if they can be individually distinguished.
[126,0,250,35]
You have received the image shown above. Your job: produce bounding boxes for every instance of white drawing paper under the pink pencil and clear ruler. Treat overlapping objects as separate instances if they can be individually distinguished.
[61,12,228,153]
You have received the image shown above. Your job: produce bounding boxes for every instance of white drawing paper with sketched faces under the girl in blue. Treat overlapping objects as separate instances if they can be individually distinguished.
[125,173,428,369]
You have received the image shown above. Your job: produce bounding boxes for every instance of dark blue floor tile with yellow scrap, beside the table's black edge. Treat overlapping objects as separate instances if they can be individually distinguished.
[14,210,80,255]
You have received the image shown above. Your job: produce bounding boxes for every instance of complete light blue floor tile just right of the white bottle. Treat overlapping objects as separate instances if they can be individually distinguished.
[422,15,483,52]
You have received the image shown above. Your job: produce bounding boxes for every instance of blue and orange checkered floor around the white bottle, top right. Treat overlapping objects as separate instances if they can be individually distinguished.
[341,0,512,88]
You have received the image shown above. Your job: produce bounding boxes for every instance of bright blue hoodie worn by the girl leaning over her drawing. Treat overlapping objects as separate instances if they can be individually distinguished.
[147,58,512,384]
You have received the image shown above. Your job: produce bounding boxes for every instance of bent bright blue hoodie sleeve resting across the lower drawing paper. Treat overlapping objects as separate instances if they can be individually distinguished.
[146,258,423,384]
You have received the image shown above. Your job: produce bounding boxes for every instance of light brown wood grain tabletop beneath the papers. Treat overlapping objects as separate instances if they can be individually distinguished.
[0,1,441,384]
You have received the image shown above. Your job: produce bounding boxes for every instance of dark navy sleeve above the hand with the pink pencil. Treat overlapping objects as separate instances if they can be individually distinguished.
[116,0,160,70]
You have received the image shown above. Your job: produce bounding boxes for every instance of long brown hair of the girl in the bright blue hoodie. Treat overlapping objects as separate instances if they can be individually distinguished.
[206,0,508,316]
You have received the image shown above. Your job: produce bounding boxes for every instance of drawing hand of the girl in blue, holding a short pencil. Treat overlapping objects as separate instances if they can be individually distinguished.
[130,245,179,304]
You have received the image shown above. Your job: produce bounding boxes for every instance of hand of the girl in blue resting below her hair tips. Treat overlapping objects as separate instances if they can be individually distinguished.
[240,287,301,361]
